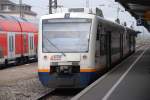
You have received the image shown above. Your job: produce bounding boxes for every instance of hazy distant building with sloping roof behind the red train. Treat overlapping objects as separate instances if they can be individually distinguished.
[0,0,37,19]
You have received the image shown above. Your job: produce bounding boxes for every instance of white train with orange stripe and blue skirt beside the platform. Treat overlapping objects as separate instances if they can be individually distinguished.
[38,9,137,88]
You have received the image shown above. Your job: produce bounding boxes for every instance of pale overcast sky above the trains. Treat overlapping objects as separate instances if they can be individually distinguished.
[11,0,147,32]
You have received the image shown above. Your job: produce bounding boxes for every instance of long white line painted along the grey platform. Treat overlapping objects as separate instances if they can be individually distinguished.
[102,48,148,100]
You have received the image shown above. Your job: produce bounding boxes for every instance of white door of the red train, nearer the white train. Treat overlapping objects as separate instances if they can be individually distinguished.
[28,33,35,56]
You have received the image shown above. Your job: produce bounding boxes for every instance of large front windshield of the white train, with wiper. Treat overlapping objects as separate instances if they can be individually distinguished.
[42,18,92,53]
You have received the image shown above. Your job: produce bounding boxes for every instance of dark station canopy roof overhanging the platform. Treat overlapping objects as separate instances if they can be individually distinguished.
[115,0,150,31]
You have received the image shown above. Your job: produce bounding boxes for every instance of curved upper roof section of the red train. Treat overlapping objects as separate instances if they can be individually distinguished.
[0,15,38,32]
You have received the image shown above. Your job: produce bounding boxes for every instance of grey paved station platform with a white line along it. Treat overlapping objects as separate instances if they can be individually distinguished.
[71,46,150,100]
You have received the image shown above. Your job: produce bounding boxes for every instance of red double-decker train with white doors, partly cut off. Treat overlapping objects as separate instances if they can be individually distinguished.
[0,15,38,66]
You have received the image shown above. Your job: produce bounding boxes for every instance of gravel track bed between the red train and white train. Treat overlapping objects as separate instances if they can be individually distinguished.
[0,63,80,100]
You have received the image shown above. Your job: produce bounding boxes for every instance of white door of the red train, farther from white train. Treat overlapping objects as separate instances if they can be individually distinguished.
[7,33,15,59]
